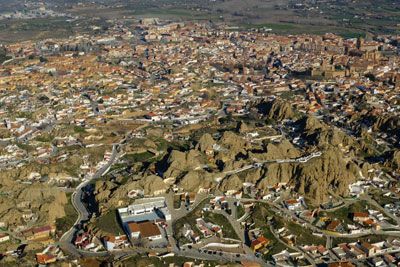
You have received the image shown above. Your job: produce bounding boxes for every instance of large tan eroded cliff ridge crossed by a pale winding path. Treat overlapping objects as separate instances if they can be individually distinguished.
[158,126,360,203]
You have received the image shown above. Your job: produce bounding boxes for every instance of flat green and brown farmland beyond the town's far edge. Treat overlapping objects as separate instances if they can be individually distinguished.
[0,0,400,43]
